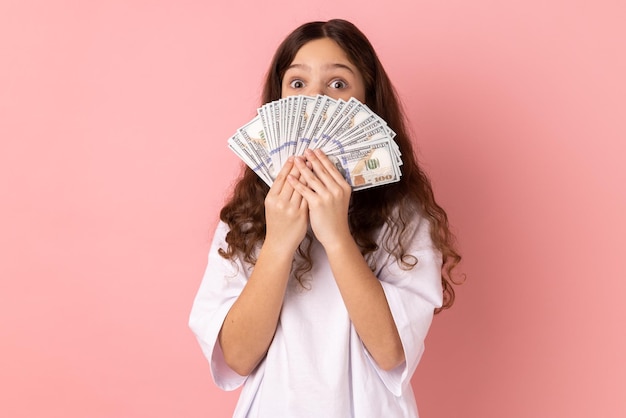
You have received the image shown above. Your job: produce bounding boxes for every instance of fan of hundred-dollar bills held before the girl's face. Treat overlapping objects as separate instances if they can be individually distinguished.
[228,95,402,190]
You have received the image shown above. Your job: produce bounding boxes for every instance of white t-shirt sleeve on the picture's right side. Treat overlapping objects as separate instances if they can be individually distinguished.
[373,218,443,396]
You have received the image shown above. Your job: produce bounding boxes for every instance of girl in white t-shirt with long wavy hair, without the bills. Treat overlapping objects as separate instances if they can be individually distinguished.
[189,20,460,418]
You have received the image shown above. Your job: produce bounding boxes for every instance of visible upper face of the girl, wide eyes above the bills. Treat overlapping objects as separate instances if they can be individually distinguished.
[281,38,365,103]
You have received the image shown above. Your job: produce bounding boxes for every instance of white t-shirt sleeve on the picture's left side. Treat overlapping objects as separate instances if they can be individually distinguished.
[189,222,248,390]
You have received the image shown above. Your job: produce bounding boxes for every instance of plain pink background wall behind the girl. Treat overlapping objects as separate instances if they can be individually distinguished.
[0,0,626,418]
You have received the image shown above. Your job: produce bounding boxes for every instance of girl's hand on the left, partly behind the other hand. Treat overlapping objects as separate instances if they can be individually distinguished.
[265,157,308,253]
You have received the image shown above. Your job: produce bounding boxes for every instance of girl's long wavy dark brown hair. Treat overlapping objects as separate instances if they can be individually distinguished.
[220,19,461,312]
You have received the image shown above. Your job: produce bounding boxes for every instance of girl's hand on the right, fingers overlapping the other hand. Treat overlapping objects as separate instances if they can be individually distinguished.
[288,149,352,250]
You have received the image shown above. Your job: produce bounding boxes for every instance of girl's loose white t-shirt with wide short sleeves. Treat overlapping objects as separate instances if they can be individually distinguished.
[189,214,442,418]
